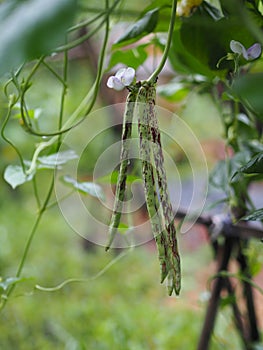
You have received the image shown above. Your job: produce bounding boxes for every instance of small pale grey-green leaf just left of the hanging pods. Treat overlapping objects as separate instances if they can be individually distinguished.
[62,175,105,201]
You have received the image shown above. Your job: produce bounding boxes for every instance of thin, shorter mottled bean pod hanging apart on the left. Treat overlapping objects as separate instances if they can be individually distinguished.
[105,86,138,251]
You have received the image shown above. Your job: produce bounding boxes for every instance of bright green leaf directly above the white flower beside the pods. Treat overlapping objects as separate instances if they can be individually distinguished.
[108,44,148,70]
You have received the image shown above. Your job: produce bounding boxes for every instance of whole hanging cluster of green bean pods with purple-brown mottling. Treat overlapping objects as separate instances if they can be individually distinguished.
[106,81,181,295]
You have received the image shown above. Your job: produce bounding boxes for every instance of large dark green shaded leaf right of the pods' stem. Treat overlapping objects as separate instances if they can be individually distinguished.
[181,2,255,75]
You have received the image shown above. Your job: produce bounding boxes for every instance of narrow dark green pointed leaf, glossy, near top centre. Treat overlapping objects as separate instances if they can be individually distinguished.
[114,8,159,47]
